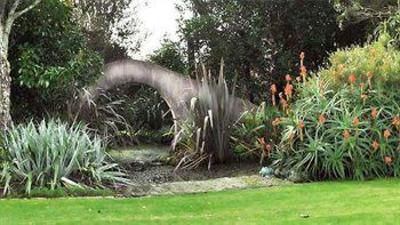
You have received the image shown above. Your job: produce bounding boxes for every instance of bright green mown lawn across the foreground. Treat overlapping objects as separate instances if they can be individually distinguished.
[0,179,400,225]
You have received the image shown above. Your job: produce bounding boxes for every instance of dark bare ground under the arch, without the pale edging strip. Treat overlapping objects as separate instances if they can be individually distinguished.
[110,146,260,185]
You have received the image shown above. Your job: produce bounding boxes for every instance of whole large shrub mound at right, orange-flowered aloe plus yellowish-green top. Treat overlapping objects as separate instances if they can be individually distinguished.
[273,40,400,180]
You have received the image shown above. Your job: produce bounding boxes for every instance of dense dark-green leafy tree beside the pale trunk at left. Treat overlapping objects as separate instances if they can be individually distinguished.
[9,0,102,121]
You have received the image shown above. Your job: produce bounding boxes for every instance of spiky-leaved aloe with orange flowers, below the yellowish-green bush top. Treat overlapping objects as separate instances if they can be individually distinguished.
[273,71,400,180]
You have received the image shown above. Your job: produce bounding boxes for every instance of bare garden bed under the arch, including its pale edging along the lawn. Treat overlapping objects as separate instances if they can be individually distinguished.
[110,146,272,196]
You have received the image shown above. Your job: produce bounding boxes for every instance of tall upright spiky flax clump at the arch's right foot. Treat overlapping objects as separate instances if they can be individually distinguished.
[173,62,238,168]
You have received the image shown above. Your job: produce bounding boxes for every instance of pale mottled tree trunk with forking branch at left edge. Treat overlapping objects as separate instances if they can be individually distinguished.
[0,0,41,130]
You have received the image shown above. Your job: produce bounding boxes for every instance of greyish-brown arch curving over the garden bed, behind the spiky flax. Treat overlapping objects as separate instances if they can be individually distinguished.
[81,60,254,131]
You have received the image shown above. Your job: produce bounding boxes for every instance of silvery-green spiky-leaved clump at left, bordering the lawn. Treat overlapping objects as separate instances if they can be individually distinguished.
[0,120,126,194]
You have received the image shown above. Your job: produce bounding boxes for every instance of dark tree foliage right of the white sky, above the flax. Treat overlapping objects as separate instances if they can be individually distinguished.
[181,0,368,102]
